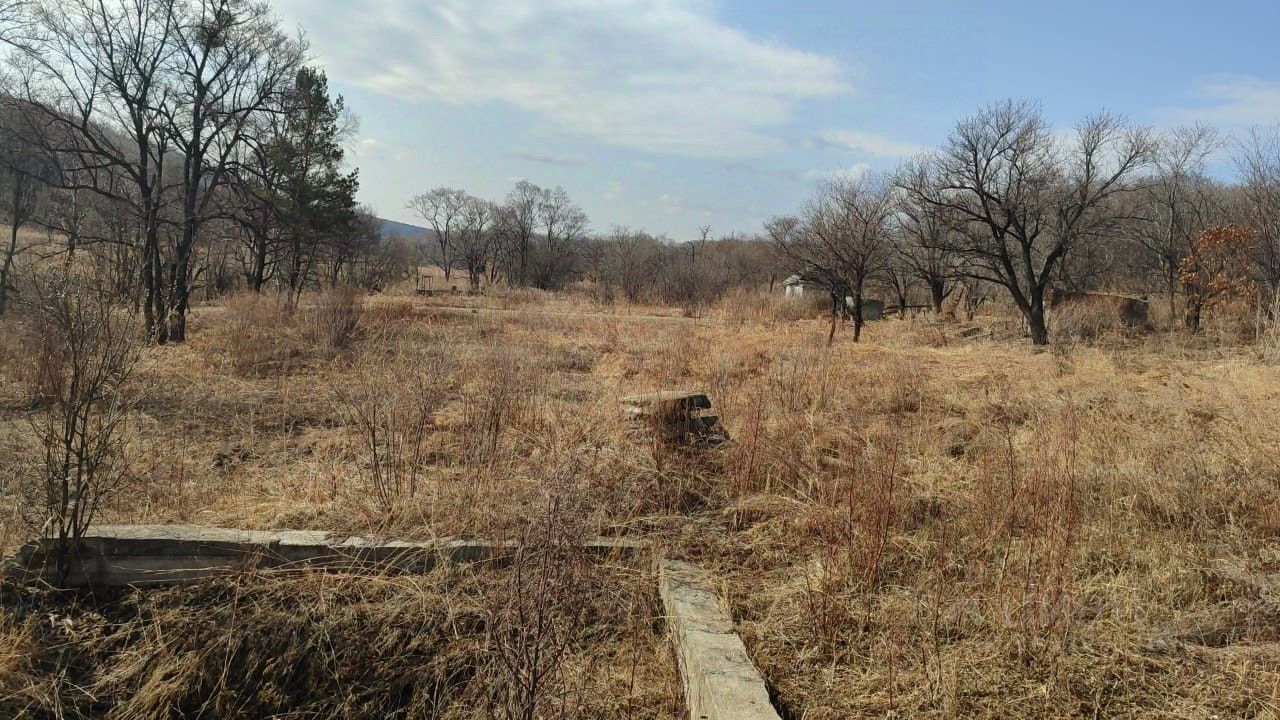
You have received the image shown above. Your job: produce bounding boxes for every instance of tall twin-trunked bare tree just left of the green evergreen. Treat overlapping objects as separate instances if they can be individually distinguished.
[10,0,302,342]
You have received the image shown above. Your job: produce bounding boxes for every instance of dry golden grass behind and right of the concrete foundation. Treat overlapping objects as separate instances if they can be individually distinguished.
[0,288,1280,719]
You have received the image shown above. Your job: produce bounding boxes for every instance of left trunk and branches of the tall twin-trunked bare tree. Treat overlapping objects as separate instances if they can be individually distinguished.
[18,0,183,342]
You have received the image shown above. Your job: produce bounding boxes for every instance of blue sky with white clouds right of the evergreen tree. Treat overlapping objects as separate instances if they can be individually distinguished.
[273,0,1280,241]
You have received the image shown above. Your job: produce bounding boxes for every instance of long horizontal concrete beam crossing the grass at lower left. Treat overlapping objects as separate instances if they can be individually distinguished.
[3,525,649,588]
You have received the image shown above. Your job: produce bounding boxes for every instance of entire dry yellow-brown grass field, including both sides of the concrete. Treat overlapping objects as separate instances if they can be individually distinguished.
[0,283,1280,720]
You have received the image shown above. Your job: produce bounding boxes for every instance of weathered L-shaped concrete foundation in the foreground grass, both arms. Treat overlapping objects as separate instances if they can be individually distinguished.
[3,525,780,720]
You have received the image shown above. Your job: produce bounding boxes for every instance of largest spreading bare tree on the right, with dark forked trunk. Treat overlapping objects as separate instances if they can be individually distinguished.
[900,101,1155,345]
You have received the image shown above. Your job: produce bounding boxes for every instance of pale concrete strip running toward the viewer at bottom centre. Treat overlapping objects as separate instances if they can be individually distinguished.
[658,560,781,720]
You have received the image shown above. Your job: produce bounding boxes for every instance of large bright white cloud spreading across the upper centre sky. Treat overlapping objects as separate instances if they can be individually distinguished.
[276,0,849,156]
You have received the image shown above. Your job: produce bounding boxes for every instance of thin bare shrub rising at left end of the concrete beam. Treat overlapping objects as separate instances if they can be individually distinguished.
[19,275,143,579]
